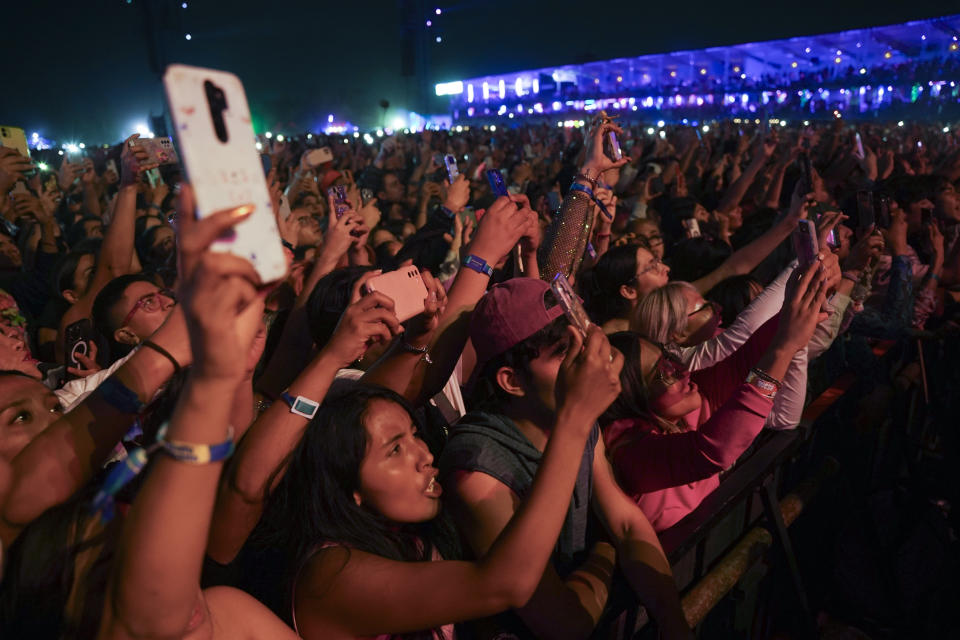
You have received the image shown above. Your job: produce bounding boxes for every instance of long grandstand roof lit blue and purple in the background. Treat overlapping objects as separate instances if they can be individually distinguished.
[435,14,960,108]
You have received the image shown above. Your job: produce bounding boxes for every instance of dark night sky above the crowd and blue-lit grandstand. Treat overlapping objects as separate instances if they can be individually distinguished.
[0,0,960,144]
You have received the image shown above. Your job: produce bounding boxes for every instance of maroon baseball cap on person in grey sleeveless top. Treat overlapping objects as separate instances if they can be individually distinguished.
[470,278,563,370]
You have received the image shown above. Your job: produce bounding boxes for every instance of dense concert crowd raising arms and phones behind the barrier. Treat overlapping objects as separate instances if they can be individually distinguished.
[0,96,960,640]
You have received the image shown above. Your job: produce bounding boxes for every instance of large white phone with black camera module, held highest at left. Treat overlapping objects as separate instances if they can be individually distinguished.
[163,64,287,282]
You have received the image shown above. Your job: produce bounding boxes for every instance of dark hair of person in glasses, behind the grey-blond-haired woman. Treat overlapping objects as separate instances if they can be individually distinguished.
[577,243,644,324]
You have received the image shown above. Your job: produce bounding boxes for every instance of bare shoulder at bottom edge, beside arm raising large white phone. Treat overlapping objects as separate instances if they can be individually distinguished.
[203,587,297,640]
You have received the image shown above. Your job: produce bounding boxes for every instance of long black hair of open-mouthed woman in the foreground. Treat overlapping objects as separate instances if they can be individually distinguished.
[261,384,460,638]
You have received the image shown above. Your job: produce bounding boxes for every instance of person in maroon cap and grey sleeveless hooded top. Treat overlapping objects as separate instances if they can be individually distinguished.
[439,278,690,638]
